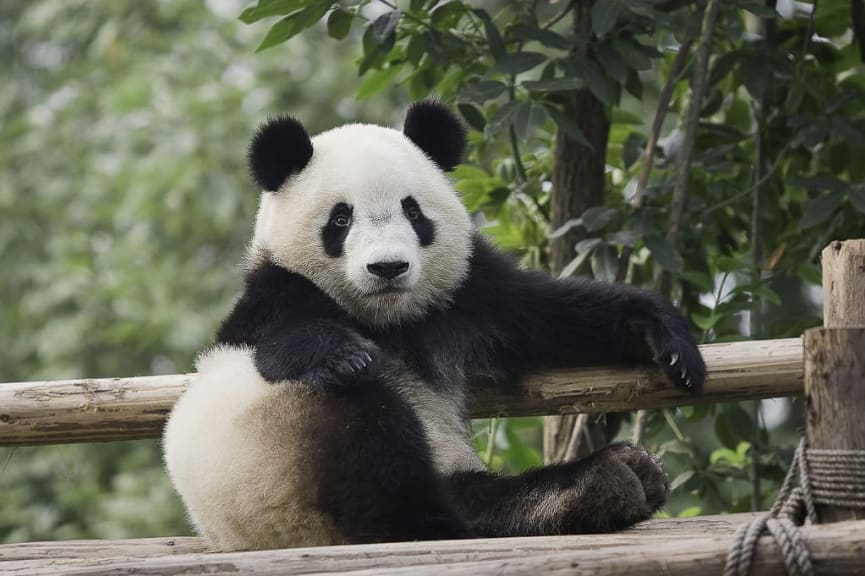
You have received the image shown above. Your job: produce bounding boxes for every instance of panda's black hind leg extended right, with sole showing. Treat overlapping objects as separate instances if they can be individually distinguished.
[448,444,668,537]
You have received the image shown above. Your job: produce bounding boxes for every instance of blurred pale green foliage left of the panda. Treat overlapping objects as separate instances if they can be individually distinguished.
[0,0,393,541]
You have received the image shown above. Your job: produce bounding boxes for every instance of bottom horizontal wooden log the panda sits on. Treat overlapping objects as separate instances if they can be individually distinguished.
[0,521,865,576]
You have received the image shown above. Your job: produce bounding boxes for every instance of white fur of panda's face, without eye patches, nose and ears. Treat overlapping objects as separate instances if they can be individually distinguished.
[252,124,472,324]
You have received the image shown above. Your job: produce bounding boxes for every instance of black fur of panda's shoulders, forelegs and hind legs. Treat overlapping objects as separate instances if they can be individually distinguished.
[217,232,705,542]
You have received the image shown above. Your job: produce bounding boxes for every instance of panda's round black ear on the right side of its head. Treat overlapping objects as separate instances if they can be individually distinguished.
[403,101,466,172]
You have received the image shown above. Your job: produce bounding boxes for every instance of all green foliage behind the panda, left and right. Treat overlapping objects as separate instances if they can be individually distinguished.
[0,0,865,541]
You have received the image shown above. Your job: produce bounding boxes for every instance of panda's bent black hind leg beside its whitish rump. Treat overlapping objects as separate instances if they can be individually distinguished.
[306,380,472,543]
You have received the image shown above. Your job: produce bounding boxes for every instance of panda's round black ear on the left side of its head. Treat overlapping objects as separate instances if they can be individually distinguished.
[248,116,312,192]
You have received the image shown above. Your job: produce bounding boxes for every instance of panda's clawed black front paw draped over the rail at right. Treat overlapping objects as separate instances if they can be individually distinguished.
[647,305,706,392]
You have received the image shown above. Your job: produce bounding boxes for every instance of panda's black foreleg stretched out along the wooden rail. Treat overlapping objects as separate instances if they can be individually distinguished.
[470,248,706,391]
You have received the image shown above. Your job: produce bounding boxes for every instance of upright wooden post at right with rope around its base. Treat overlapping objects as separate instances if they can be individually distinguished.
[804,240,865,522]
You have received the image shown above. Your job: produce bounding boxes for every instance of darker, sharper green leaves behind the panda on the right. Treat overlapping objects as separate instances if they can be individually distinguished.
[246,0,865,514]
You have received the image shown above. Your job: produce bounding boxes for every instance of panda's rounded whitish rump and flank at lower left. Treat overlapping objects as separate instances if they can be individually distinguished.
[163,347,341,550]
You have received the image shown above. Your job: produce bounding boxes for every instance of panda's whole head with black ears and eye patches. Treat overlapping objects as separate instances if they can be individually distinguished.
[243,103,472,325]
